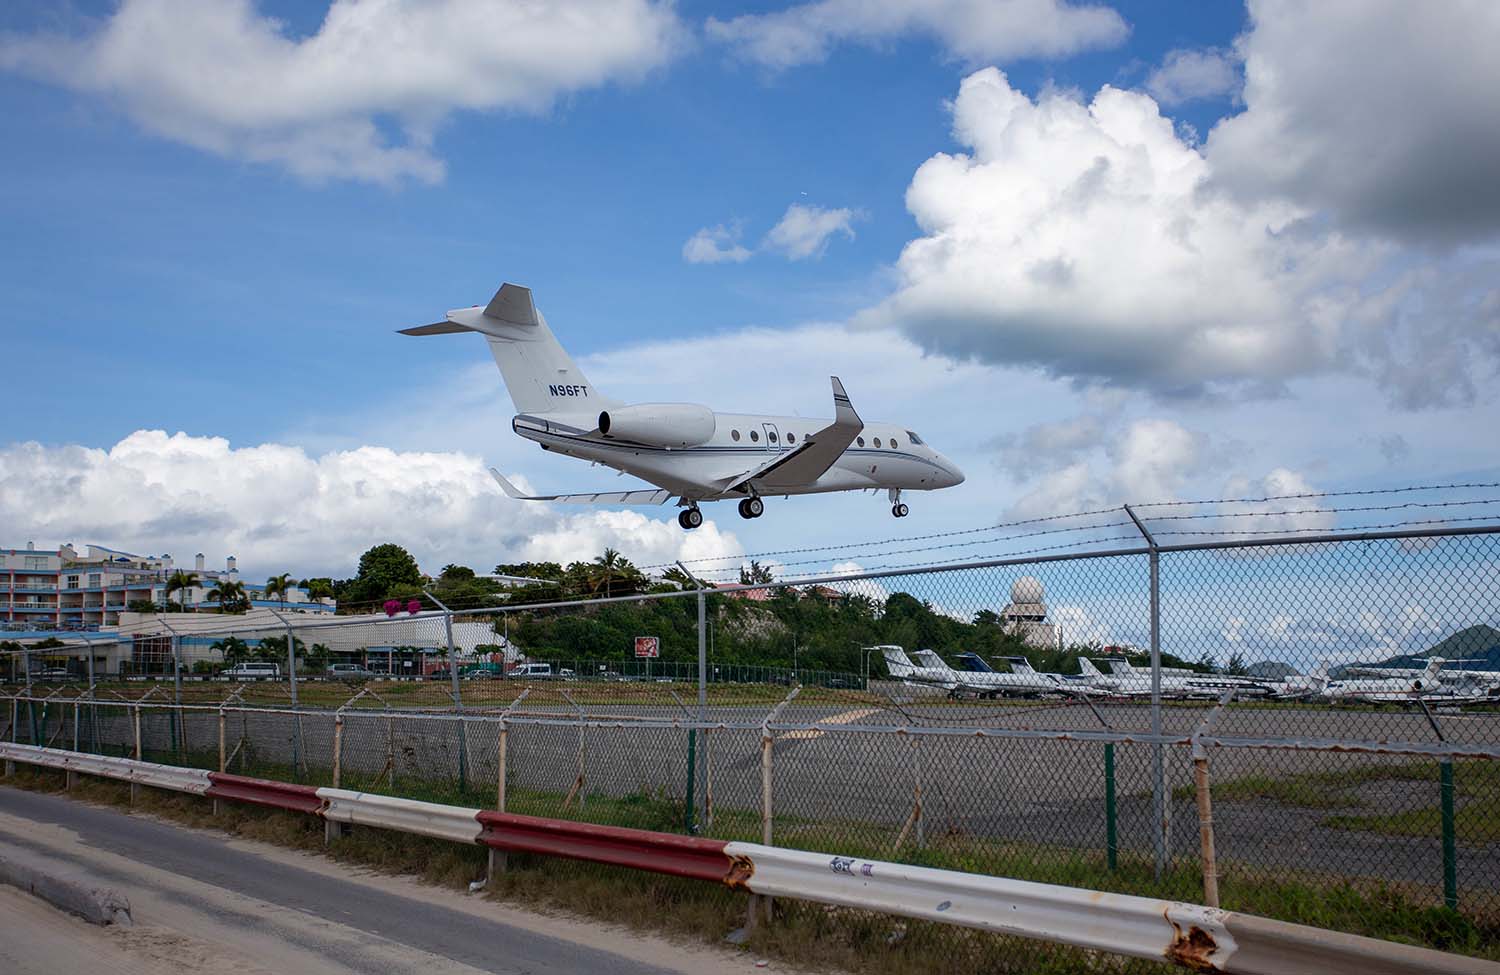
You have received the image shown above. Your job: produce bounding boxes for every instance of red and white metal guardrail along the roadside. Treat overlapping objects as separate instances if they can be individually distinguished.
[0,743,1500,975]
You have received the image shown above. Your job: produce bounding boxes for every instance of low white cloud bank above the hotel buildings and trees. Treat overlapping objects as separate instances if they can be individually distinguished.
[0,431,741,576]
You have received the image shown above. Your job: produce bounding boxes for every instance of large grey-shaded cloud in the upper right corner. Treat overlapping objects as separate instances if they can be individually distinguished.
[1208,0,1500,242]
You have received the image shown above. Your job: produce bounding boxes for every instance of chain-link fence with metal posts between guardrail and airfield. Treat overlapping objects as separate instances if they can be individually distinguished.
[0,513,1500,954]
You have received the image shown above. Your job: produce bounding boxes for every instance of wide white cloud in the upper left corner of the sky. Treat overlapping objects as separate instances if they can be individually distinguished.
[0,0,684,185]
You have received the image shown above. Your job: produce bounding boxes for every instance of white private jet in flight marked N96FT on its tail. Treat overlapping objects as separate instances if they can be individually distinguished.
[401,284,963,530]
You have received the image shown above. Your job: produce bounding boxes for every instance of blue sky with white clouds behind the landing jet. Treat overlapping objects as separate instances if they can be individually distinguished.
[0,0,1500,600]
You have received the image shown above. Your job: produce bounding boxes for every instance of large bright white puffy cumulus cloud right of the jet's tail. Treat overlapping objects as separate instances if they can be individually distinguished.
[855,68,1500,405]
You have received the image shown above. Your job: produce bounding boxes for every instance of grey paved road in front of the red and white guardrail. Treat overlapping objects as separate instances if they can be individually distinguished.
[0,788,755,975]
